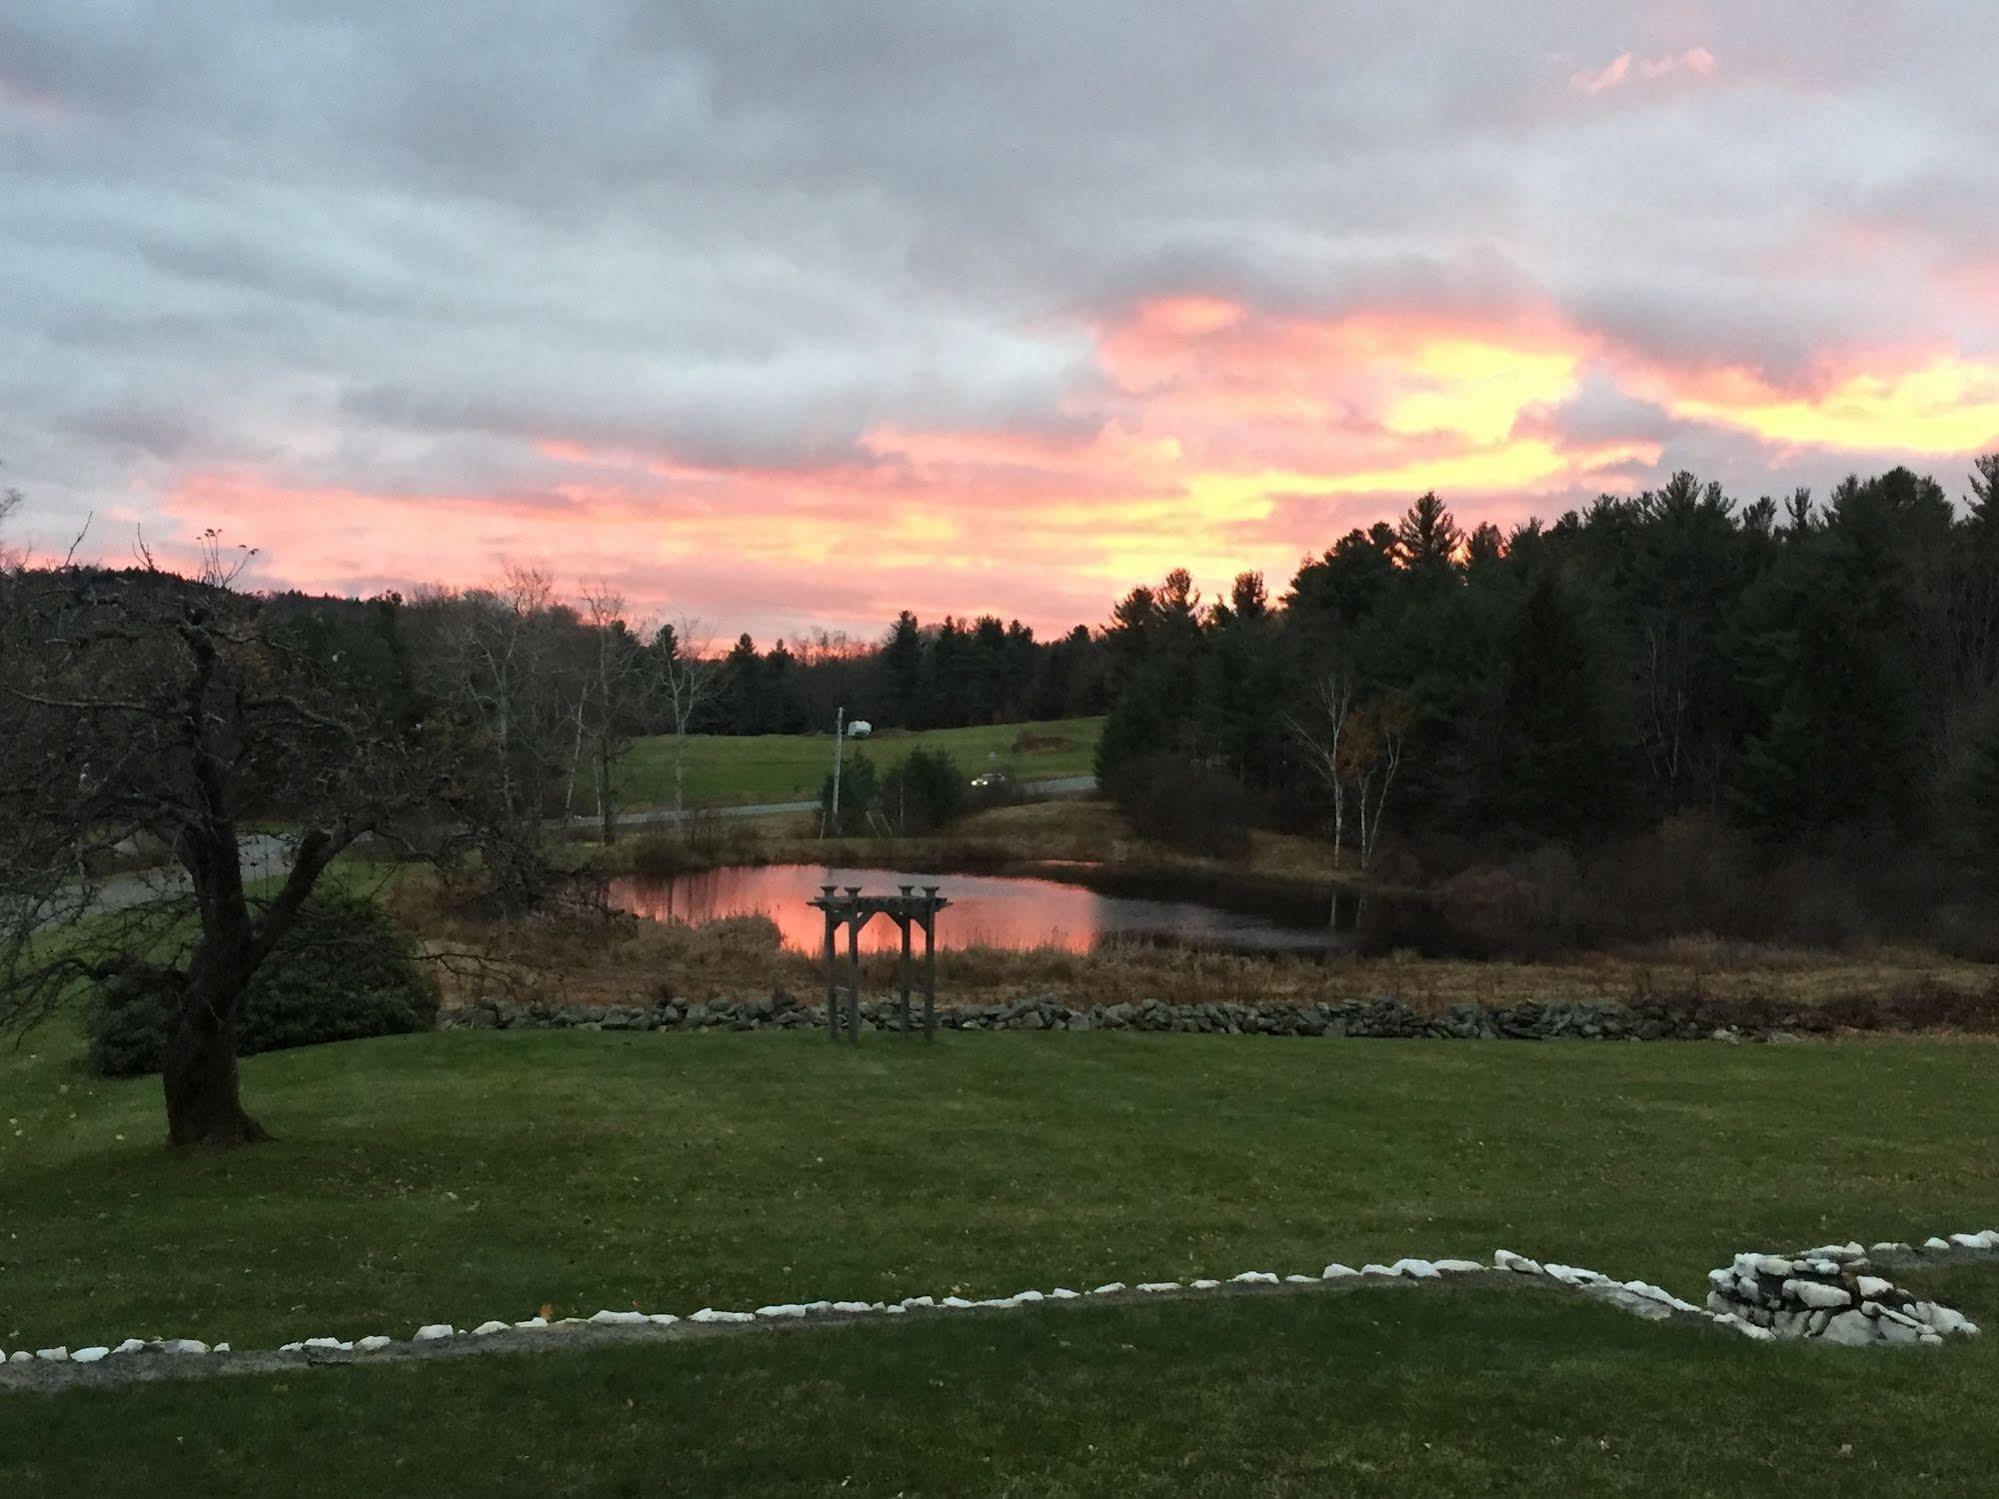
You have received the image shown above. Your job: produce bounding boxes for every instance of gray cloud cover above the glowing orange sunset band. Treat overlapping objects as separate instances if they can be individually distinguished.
[0,0,1999,611]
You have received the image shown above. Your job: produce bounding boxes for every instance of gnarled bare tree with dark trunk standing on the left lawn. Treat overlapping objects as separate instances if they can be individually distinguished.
[0,559,438,1145]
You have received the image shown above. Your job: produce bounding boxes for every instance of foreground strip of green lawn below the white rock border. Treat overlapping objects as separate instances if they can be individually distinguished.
[11,1289,1999,1499]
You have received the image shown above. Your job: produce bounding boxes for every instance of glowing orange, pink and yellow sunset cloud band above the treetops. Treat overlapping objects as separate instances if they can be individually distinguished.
[166,298,1999,638]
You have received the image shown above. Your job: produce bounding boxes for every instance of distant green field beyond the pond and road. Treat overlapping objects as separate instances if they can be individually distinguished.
[620,718,1103,811]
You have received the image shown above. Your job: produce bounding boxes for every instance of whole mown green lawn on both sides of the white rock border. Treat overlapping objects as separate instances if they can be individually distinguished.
[0,1031,1999,1495]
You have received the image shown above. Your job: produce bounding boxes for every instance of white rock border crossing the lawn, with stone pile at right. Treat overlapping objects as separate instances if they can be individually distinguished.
[0,1229,1999,1387]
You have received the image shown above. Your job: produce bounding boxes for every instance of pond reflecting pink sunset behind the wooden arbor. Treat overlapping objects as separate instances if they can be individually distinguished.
[610,863,1327,953]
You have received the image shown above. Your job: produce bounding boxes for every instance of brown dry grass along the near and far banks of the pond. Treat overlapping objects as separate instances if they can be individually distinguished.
[396,799,1999,1013]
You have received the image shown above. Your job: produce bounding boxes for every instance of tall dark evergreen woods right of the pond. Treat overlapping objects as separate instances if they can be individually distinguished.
[1099,456,1999,911]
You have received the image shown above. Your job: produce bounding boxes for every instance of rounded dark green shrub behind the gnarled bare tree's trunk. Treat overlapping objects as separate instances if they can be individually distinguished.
[86,895,438,1077]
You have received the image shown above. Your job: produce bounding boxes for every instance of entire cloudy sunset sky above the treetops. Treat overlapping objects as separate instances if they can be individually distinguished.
[0,0,1999,638]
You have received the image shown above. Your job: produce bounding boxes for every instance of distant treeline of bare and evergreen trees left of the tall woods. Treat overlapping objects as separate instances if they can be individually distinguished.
[6,543,1107,879]
